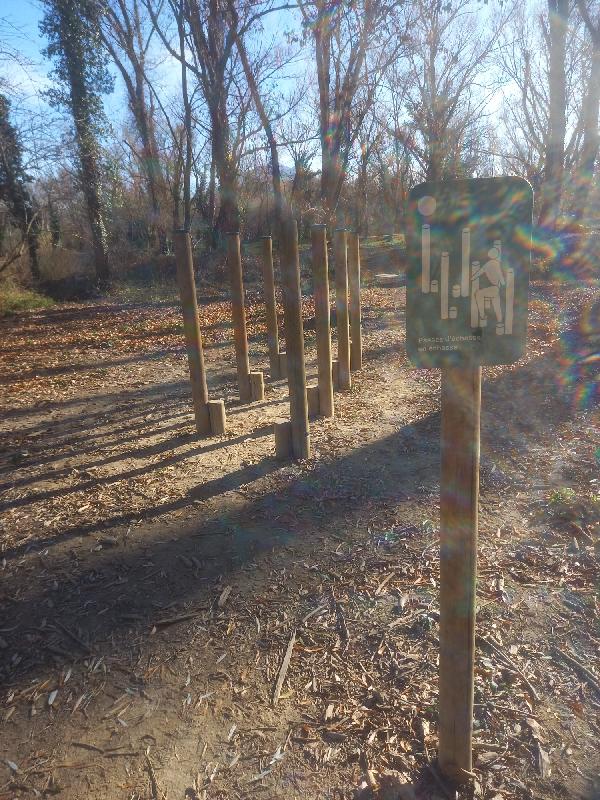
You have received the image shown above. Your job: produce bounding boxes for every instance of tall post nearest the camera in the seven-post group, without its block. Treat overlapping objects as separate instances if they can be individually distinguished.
[281,219,310,459]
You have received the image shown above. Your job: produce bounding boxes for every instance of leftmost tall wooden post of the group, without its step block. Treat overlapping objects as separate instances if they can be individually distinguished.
[173,230,211,436]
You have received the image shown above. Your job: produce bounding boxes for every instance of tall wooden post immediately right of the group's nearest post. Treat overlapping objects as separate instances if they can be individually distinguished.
[311,225,334,417]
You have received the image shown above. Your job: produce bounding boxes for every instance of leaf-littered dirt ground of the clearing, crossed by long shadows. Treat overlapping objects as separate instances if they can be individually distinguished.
[0,270,600,800]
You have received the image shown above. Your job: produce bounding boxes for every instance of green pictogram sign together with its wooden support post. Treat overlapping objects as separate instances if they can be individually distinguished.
[406,178,533,783]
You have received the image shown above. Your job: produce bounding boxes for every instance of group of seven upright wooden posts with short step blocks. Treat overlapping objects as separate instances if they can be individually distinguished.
[175,220,362,459]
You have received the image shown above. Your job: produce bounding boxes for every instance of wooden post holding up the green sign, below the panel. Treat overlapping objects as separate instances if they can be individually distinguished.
[438,364,481,783]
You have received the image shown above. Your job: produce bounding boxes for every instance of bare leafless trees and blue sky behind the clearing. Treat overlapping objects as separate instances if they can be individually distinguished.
[0,0,600,286]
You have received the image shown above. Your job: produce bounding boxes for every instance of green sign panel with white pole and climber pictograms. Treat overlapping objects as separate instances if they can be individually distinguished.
[406,178,533,367]
